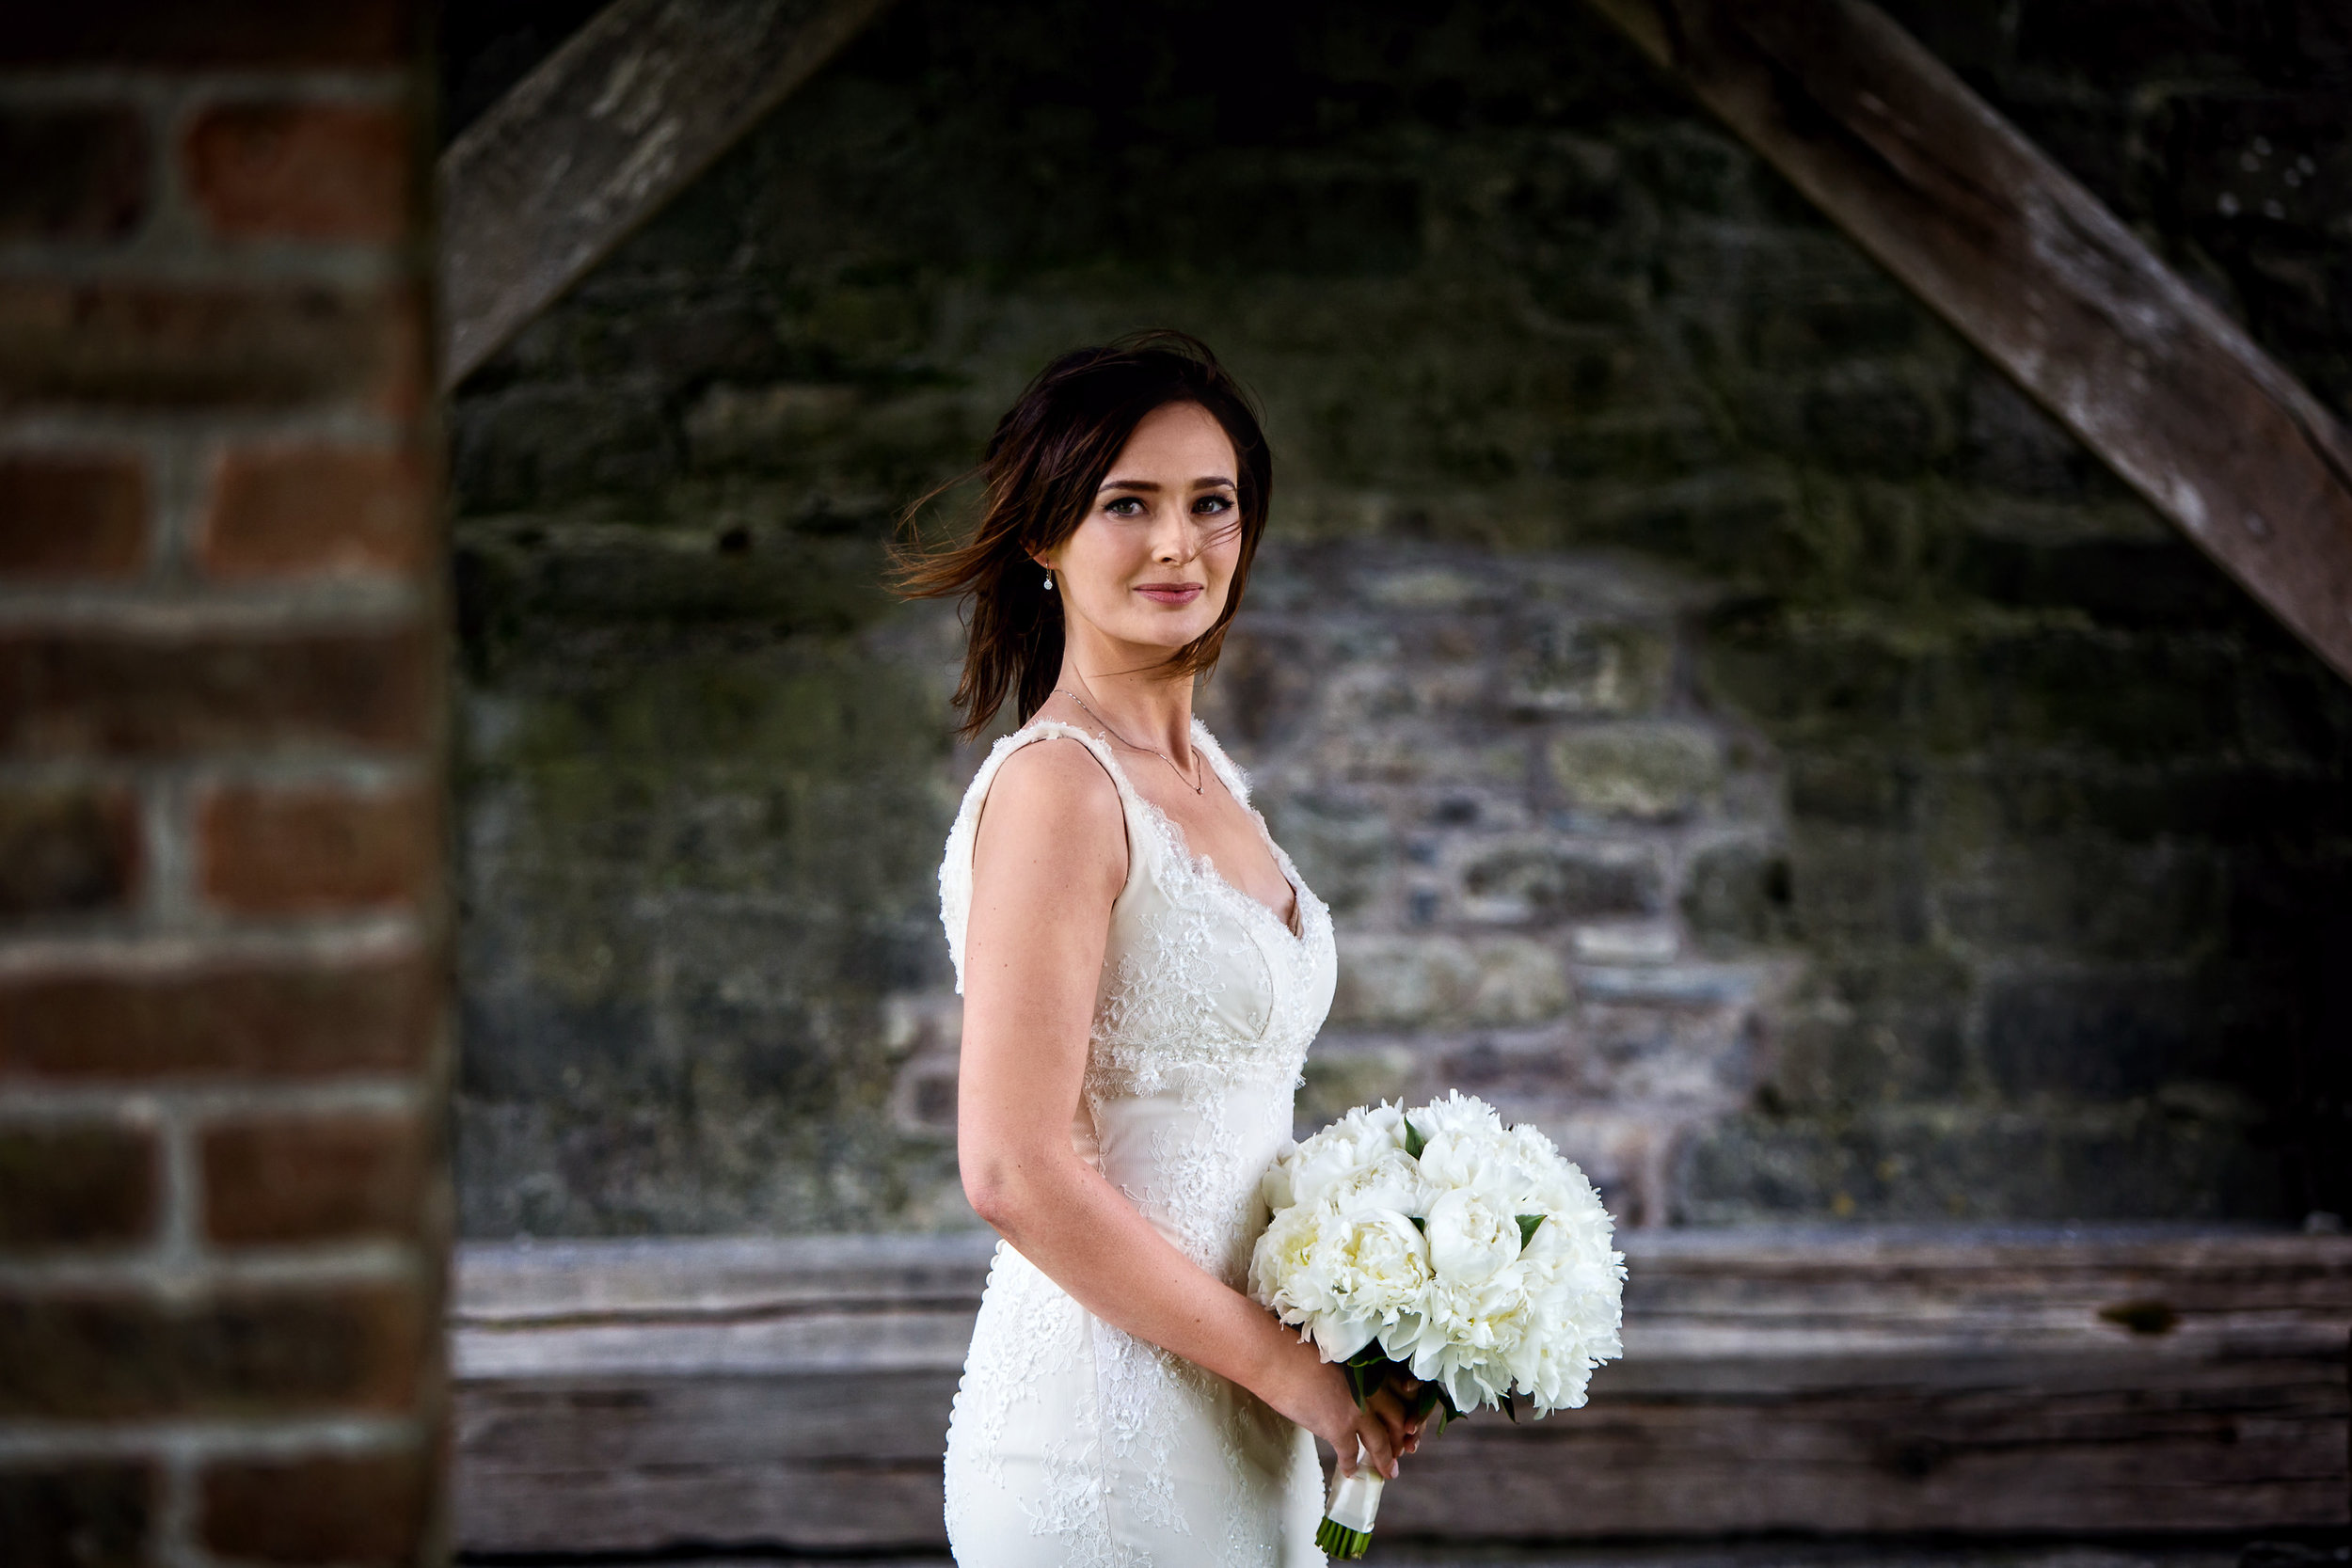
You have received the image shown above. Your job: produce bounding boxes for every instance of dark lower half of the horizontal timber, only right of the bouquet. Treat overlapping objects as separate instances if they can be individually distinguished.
[1383,1359,2345,1540]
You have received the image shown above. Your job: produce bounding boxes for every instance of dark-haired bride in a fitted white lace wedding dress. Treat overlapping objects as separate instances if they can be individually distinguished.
[901,331,1419,1568]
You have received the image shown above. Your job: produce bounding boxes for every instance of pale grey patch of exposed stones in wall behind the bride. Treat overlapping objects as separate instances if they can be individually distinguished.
[1204,541,1769,1225]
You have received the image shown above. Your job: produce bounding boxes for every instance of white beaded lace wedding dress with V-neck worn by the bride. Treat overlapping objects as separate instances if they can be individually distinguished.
[939,721,1334,1568]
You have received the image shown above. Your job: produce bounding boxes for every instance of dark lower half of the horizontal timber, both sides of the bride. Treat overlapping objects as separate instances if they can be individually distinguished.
[459,1359,2345,1552]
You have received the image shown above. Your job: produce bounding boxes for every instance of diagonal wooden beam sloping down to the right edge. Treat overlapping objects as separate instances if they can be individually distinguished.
[1588,0,2352,679]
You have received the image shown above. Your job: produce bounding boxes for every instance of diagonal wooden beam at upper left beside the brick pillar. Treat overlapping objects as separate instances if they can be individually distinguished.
[437,0,889,390]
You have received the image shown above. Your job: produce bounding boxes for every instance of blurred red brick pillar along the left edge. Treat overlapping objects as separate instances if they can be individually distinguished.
[0,0,450,1568]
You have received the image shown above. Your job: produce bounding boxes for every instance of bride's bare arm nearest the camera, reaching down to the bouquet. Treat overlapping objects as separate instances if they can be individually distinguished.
[955,740,1411,1477]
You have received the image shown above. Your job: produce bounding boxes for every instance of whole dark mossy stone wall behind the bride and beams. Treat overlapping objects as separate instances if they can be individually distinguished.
[452,0,2352,1234]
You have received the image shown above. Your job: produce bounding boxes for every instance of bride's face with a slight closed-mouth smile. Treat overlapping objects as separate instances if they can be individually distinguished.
[1038,402,1242,651]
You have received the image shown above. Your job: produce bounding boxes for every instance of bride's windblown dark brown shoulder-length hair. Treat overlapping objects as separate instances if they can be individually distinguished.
[892,331,1275,738]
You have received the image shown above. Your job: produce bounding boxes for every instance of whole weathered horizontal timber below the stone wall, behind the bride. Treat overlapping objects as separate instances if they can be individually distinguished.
[454,1227,2352,1552]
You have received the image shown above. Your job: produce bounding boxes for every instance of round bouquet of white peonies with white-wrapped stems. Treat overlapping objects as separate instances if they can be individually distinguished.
[1249,1093,1626,1559]
